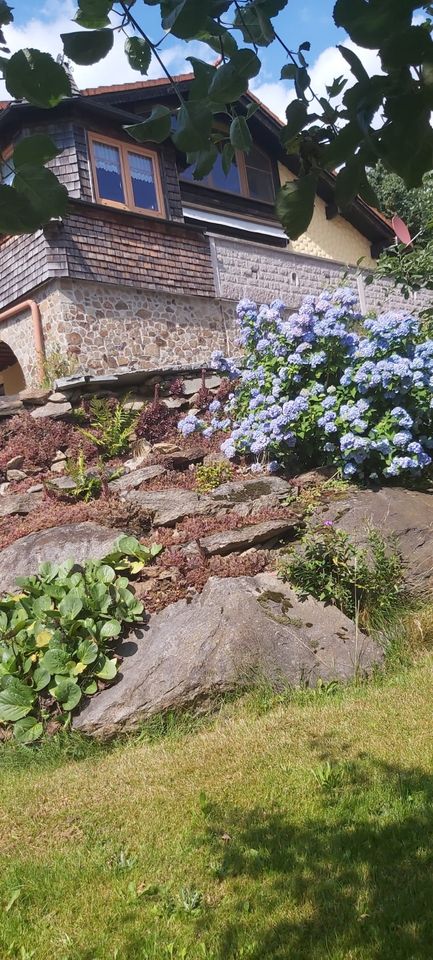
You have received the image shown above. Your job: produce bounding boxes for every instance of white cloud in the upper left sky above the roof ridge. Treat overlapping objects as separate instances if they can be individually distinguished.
[0,0,200,99]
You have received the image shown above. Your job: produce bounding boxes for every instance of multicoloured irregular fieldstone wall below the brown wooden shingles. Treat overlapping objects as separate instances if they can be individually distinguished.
[38,280,235,373]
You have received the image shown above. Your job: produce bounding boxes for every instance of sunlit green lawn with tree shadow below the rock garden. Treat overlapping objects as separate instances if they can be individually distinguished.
[0,654,433,960]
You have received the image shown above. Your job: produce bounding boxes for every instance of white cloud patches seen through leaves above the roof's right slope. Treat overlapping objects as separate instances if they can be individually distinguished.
[251,40,381,120]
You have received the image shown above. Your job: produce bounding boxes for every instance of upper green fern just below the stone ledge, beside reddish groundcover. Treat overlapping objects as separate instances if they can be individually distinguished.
[79,397,139,459]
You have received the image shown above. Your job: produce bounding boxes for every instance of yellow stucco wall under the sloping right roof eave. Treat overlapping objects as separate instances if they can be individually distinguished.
[278,163,376,267]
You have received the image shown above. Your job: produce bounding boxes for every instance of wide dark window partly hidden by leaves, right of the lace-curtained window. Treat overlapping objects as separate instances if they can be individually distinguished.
[179,144,275,203]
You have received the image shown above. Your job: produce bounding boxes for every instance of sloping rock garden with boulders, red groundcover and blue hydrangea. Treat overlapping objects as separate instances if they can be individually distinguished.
[0,288,433,743]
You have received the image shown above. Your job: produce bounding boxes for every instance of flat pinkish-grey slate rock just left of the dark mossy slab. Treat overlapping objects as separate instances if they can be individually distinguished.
[125,487,215,527]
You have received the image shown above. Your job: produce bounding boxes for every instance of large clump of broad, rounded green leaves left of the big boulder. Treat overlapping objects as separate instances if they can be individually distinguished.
[0,537,158,743]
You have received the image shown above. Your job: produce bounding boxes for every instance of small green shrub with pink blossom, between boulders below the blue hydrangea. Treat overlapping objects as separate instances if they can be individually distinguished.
[278,523,403,629]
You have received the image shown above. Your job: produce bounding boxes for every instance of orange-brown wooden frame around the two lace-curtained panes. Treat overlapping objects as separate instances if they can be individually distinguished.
[87,131,165,219]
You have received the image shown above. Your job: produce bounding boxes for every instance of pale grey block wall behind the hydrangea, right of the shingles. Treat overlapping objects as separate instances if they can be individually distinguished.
[210,235,433,311]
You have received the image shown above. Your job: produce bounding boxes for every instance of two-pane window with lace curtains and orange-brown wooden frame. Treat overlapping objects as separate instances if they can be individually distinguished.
[89,133,164,217]
